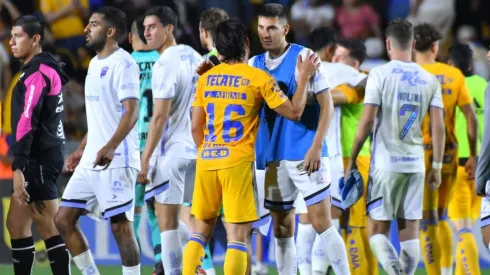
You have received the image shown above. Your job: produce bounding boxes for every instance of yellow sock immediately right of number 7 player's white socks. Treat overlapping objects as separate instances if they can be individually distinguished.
[420,221,441,275]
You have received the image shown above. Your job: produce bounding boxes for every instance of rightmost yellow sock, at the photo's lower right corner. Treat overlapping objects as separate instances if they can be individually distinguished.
[456,228,480,275]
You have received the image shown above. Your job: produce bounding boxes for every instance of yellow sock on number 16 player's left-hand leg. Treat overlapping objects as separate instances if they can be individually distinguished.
[182,233,207,275]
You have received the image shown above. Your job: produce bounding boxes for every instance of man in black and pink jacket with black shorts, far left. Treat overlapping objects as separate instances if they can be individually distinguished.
[7,16,70,275]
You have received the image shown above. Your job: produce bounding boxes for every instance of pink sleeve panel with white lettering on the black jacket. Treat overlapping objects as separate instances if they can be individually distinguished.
[15,71,46,141]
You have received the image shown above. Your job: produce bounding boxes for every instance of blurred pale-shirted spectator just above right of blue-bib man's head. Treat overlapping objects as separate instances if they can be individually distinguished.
[290,0,335,44]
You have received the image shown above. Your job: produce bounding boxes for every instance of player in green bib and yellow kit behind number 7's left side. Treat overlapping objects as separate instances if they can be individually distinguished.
[329,40,378,274]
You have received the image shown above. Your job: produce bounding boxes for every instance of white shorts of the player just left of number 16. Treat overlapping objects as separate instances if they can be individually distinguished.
[145,156,196,204]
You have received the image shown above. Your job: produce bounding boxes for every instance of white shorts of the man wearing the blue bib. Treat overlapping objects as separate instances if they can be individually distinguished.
[264,158,330,211]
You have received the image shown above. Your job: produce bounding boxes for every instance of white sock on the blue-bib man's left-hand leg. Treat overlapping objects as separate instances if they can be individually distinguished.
[275,237,298,275]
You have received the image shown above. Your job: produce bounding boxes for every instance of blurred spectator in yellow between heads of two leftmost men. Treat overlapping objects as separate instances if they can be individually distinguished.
[40,0,89,53]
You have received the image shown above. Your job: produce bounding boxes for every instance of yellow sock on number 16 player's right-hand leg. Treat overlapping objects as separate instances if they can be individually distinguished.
[224,242,248,275]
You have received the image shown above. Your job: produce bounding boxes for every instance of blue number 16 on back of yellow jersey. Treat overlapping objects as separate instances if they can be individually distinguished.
[204,103,245,143]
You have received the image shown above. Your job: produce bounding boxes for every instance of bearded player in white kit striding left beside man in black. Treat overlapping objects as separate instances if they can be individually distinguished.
[55,7,140,275]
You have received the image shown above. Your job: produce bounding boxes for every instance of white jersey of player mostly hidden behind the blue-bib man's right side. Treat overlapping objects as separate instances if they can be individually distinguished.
[322,62,366,157]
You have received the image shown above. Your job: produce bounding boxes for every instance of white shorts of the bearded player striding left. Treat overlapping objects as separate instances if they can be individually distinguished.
[60,167,138,221]
